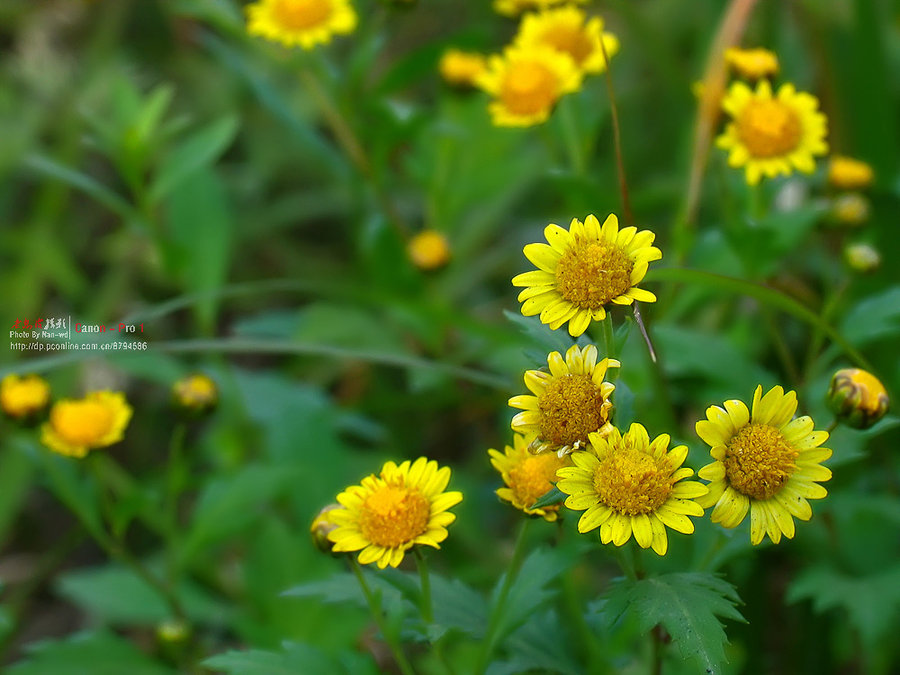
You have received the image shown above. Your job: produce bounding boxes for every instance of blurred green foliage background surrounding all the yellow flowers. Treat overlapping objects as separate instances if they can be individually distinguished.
[0,0,900,674]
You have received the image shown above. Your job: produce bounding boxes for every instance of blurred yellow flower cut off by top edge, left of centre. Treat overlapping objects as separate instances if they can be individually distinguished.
[246,0,356,49]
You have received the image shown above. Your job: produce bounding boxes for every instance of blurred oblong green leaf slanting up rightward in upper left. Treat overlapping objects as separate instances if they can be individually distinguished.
[150,115,238,203]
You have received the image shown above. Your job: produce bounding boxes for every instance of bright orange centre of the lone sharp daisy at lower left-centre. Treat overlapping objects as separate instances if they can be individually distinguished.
[360,483,431,548]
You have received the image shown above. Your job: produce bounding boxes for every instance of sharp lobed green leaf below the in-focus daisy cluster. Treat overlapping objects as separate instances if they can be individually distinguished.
[603,572,744,675]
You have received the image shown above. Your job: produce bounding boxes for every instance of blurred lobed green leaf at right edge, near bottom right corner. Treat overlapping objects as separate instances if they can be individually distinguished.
[787,564,900,651]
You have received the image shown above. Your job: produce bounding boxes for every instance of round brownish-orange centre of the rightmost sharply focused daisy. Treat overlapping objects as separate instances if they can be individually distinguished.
[724,424,799,500]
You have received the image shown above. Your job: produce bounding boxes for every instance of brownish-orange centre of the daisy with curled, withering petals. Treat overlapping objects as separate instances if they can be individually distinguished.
[538,375,612,447]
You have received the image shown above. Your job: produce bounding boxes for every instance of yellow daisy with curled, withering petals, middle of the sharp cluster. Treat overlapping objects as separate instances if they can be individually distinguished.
[509,345,620,457]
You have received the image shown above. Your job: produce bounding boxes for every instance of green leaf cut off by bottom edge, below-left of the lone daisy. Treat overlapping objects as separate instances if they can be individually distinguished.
[203,642,378,675]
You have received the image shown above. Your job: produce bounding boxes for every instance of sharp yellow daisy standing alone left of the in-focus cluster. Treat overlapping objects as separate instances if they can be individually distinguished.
[328,457,462,569]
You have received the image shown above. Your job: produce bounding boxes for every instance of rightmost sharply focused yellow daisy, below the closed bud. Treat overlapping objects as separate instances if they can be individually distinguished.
[696,386,831,545]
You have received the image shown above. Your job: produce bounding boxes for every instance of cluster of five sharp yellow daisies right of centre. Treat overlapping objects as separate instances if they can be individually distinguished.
[489,215,831,555]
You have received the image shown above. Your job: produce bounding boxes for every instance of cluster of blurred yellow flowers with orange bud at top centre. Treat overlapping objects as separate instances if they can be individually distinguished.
[440,5,619,127]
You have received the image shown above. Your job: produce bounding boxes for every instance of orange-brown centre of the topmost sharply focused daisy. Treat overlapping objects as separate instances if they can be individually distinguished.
[556,242,634,309]
